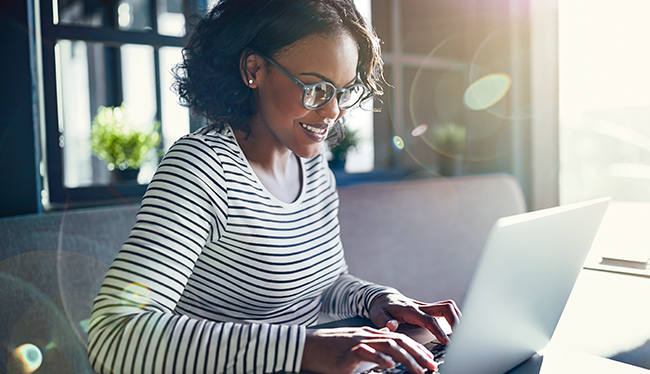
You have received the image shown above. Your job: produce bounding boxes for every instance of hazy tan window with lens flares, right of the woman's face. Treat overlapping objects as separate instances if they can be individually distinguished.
[372,0,527,176]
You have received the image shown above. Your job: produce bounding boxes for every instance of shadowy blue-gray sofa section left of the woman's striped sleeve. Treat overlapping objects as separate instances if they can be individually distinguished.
[0,206,138,374]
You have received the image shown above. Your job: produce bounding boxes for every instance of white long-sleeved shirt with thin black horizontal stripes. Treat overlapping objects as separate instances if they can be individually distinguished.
[88,127,396,373]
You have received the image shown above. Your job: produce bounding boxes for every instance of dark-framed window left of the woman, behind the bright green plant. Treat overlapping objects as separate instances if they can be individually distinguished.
[40,0,197,208]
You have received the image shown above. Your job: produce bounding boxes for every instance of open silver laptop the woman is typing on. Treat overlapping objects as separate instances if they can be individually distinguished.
[360,198,610,374]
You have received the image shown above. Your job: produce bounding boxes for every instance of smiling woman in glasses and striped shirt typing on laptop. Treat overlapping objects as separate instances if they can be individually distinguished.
[88,0,459,374]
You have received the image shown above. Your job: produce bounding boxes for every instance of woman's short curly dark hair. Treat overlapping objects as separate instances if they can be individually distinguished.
[173,0,385,137]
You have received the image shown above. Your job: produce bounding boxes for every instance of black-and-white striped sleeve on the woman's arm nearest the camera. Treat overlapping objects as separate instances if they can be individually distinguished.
[88,136,305,374]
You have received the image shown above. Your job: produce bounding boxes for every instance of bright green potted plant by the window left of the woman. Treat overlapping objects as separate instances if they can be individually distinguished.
[90,105,160,180]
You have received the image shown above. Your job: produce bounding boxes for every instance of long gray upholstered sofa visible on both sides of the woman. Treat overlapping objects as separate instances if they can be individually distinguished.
[0,175,525,374]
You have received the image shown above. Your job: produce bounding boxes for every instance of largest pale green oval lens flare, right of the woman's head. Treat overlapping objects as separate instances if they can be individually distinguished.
[463,73,512,110]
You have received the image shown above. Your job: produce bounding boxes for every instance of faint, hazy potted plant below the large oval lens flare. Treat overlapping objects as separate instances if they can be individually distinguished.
[434,123,467,176]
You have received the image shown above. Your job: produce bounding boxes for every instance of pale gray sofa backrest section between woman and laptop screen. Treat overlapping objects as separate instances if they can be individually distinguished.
[339,174,526,303]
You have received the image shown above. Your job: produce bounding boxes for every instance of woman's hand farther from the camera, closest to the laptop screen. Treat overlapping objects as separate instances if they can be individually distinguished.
[370,294,461,344]
